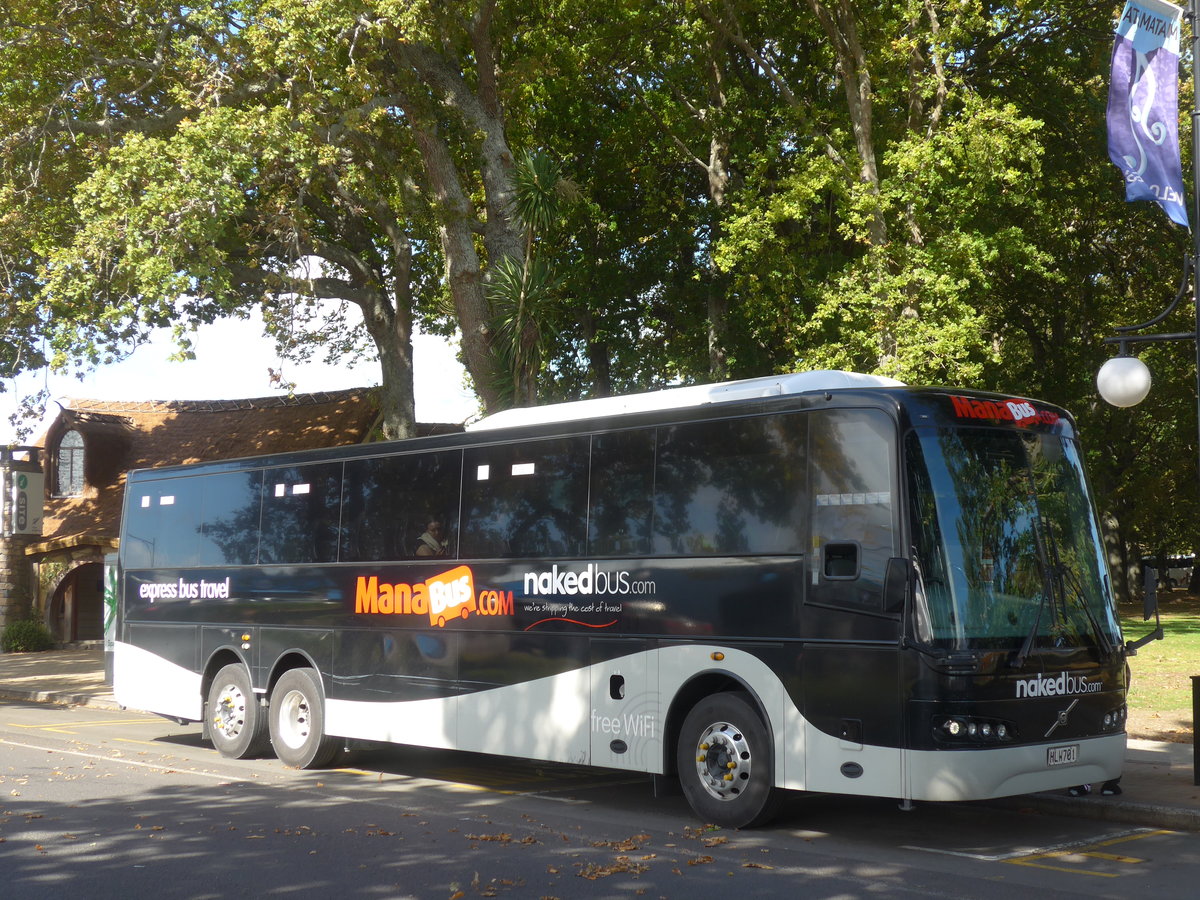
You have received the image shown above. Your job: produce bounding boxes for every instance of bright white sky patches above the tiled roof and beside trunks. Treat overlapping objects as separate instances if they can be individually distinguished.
[0,318,479,444]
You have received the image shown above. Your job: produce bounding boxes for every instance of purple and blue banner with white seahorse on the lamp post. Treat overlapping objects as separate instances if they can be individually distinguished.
[1108,0,1188,227]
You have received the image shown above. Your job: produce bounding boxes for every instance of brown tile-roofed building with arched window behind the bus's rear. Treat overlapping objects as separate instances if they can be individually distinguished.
[0,389,460,644]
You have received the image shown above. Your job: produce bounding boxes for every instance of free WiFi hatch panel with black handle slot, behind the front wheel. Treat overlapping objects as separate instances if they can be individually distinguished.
[588,637,662,772]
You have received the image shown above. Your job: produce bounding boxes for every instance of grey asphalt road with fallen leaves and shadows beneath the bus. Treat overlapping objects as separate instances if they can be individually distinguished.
[0,703,1200,900]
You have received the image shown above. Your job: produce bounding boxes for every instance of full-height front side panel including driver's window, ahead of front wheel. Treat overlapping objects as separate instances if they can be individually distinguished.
[800,409,902,797]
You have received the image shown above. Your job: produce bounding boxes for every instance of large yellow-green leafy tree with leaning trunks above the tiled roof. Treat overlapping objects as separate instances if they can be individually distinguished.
[0,0,580,437]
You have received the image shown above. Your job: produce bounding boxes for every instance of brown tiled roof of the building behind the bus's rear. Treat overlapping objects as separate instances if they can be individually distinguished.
[31,388,388,553]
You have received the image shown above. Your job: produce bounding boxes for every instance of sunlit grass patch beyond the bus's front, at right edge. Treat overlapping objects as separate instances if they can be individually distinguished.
[1120,590,1200,740]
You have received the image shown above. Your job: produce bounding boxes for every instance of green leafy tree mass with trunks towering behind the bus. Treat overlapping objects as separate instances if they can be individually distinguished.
[0,0,1200,571]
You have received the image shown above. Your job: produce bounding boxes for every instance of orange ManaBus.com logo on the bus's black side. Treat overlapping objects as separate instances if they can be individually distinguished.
[354,565,512,628]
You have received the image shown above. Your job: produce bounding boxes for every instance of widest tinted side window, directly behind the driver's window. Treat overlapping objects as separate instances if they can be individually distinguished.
[654,414,805,556]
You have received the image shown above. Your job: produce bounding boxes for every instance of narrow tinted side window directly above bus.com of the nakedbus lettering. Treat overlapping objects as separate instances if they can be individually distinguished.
[588,428,654,556]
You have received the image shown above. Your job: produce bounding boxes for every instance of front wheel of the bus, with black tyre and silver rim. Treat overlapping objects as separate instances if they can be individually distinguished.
[677,692,779,828]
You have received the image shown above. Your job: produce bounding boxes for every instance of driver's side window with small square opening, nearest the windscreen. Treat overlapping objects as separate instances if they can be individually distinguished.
[809,409,895,607]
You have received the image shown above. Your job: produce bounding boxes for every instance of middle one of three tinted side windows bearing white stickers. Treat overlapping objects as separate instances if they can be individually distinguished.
[258,462,342,564]
